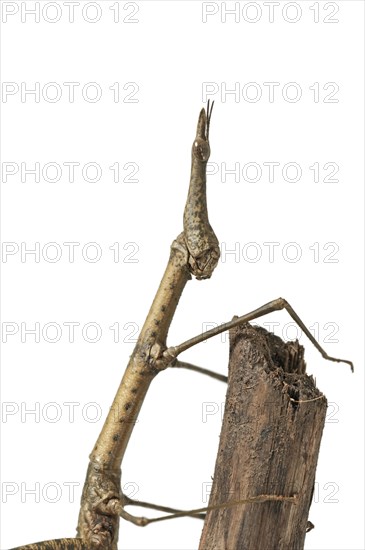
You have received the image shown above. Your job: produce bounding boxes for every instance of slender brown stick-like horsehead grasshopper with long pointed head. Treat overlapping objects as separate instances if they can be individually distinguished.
[14,102,353,550]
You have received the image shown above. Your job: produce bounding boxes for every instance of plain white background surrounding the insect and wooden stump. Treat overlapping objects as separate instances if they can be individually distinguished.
[0,0,364,550]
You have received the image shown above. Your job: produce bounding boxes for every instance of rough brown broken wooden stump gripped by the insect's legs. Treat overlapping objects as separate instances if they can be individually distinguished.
[199,324,327,550]
